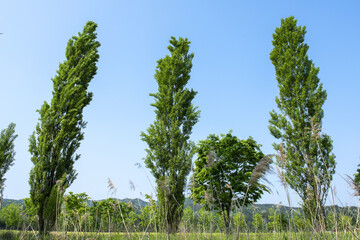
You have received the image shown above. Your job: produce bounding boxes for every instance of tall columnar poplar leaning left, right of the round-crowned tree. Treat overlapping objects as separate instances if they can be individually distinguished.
[269,17,335,230]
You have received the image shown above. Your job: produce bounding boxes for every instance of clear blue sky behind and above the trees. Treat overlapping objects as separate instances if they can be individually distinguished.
[0,0,360,205]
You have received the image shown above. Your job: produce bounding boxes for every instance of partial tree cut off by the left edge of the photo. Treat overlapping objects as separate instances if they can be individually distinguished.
[0,123,17,207]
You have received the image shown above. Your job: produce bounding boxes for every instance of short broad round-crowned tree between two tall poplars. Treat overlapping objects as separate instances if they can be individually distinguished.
[191,133,267,231]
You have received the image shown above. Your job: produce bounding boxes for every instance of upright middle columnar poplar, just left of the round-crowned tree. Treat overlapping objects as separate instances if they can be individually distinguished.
[141,37,200,233]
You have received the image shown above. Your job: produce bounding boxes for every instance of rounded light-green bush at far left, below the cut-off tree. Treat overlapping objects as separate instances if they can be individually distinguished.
[0,203,24,229]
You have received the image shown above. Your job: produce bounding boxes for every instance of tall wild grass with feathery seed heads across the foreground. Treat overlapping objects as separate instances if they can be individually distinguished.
[0,159,360,240]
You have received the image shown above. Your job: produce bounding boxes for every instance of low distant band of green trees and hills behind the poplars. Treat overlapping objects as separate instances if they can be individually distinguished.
[0,195,359,233]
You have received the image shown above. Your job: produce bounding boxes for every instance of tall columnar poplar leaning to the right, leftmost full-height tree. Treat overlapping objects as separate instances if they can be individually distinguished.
[29,22,100,233]
